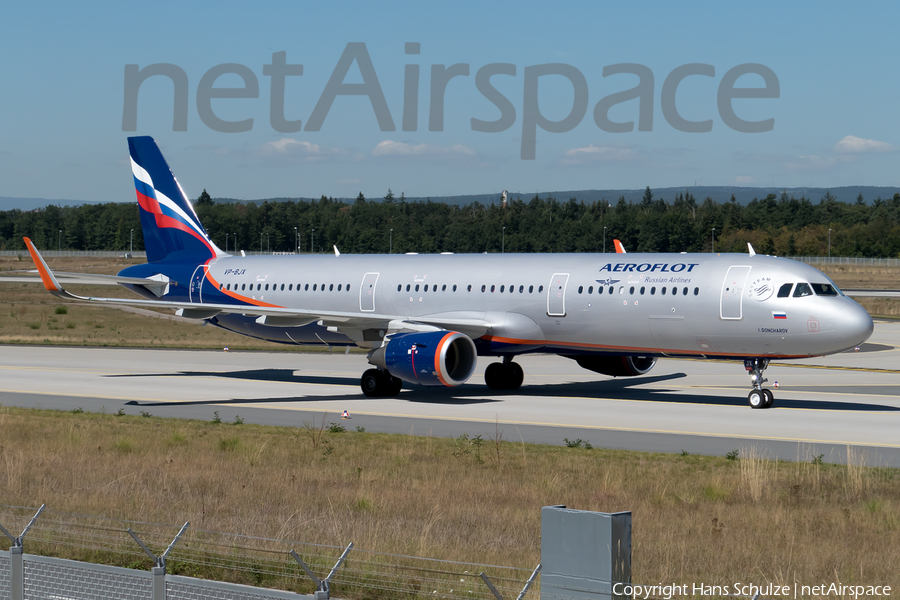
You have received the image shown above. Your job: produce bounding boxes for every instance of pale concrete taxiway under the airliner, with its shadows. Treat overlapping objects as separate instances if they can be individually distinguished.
[0,323,900,467]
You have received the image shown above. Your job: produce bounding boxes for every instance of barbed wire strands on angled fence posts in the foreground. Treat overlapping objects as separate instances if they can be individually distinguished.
[0,505,539,600]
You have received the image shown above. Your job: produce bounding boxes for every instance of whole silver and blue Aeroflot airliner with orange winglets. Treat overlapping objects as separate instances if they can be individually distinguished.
[25,137,873,408]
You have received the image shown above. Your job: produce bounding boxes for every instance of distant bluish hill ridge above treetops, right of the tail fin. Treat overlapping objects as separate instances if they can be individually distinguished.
[215,185,900,206]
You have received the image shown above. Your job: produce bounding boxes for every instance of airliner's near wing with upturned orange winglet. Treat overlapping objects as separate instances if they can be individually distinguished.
[25,238,491,338]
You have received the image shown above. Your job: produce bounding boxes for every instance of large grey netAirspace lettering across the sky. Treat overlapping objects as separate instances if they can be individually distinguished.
[122,42,781,160]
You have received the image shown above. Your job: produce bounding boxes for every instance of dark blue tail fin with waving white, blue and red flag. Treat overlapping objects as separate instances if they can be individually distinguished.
[128,136,224,263]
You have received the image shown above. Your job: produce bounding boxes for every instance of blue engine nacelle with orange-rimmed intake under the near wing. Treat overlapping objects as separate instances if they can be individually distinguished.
[369,330,478,387]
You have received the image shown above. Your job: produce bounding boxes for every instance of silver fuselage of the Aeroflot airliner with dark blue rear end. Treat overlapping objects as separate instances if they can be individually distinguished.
[121,254,872,359]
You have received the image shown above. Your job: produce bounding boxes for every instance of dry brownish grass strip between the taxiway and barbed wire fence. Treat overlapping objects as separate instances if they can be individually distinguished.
[0,408,900,589]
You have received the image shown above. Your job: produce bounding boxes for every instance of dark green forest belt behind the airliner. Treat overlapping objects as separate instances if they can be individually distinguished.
[0,187,900,258]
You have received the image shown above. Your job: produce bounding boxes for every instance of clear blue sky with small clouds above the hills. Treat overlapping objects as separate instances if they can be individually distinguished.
[0,2,900,201]
